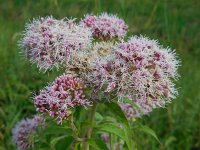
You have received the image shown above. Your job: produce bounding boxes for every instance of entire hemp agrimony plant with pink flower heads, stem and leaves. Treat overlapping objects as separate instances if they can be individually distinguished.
[12,13,179,150]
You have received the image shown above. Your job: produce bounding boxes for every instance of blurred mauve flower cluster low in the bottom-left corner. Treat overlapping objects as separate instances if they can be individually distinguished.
[12,116,43,150]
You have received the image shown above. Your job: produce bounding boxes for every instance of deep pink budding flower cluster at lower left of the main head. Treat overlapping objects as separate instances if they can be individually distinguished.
[34,74,89,124]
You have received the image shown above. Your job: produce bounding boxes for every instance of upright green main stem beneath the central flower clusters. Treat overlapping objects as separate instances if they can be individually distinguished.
[83,102,97,150]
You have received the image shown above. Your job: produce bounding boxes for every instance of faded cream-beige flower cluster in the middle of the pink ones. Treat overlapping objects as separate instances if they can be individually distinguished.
[65,42,115,85]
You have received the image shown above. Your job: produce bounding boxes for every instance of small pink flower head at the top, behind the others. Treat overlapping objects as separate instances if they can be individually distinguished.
[80,13,128,40]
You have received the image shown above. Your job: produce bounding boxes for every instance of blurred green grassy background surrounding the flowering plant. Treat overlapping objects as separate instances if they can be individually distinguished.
[0,0,200,150]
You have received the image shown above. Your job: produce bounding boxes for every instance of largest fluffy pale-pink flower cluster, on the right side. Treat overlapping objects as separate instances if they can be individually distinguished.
[92,36,179,116]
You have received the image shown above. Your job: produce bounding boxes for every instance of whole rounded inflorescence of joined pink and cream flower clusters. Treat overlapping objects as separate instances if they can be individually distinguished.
[17,13,179,123]
